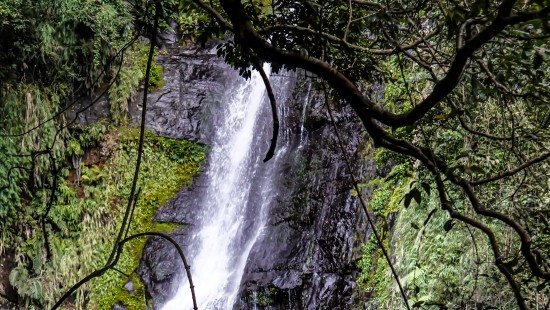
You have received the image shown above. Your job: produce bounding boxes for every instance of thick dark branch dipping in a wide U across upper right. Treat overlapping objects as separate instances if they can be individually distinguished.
[209,0,550,127]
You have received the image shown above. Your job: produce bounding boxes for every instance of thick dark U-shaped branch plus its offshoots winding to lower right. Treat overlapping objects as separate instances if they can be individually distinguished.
[195,0,550,309]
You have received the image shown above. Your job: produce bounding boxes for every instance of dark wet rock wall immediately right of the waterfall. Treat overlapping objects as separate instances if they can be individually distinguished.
[236,75,376,309]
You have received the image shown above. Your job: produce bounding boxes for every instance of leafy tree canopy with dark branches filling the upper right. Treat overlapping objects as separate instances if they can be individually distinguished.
[180,0,550,309]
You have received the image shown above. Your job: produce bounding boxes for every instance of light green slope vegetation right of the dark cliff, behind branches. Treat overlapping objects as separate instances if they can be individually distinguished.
[358,49,547,309]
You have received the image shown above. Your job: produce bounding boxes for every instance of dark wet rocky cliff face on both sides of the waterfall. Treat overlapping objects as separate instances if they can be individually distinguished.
[138,42,376,309]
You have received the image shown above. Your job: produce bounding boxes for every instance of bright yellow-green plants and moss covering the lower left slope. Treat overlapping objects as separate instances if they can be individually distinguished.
[5,124,204,309]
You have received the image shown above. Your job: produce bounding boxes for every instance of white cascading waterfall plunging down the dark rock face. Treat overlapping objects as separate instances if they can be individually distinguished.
[163,65,281,310]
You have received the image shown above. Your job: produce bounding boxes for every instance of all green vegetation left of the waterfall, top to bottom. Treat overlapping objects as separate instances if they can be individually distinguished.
[0,0,204,309]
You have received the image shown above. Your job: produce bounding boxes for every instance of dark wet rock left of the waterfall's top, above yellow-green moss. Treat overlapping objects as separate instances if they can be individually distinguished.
[130,40,242,144]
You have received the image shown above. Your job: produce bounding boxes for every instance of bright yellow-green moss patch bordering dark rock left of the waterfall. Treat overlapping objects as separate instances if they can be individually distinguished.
[90,130,205,309]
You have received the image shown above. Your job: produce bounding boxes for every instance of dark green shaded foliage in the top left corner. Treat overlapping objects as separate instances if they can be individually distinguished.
[0,0,133,87]
